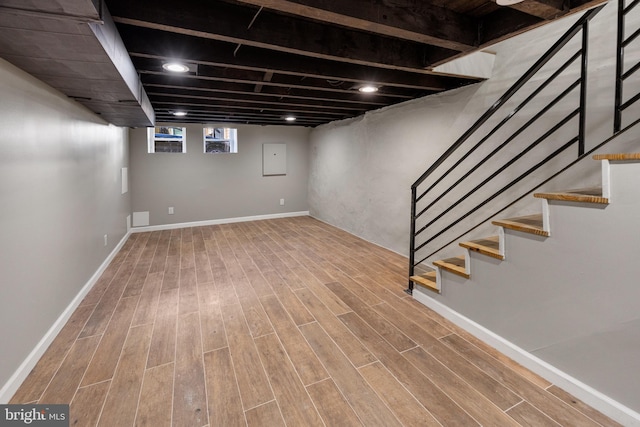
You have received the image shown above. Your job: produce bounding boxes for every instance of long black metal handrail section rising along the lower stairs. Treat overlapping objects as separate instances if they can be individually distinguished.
[407,5,608,293]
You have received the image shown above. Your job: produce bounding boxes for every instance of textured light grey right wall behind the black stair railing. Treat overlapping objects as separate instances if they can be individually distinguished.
[309,4,636,255]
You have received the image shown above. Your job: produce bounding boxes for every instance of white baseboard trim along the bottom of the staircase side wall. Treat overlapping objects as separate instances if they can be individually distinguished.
[413,287,640,426]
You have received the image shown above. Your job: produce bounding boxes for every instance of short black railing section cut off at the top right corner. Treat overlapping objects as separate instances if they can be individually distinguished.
[613,0,640,132]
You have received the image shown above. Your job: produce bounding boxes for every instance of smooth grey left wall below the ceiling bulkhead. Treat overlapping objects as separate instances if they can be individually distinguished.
[0,59,130,396]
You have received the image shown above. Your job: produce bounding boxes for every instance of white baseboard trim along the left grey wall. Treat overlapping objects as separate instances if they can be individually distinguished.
[0,233,131,404]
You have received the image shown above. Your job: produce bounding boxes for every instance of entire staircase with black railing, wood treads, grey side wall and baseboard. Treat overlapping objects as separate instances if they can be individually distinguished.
[406,0,640,426]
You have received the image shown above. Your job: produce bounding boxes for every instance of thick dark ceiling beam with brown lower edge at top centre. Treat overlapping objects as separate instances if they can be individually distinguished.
[230,0,477,51]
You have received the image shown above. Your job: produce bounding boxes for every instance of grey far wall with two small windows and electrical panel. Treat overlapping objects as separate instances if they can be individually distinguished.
[130,124,309,226]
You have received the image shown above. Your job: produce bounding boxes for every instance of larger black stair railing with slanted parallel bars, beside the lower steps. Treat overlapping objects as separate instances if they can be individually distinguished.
[407,5,608,293]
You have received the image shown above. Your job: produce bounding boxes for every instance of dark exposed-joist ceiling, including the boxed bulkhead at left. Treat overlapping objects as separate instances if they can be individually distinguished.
[0,0,603,126]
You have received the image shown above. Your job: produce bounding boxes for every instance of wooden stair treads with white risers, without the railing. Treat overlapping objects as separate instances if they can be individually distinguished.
[410,153,640,293]
